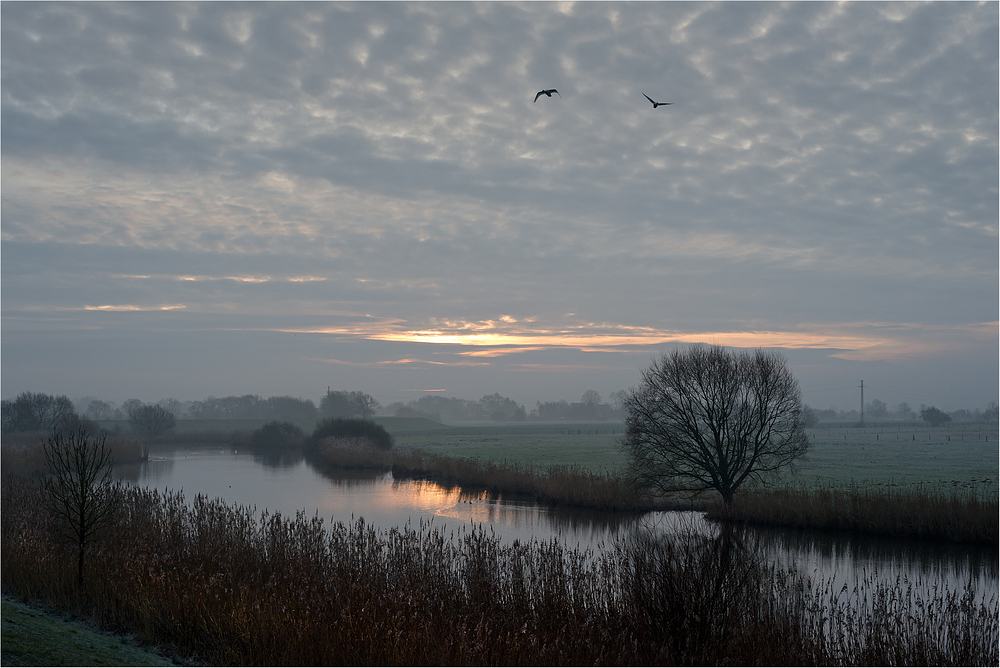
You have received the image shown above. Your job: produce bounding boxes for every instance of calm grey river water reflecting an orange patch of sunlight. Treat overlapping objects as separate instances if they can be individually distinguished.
[117,446,1000,600]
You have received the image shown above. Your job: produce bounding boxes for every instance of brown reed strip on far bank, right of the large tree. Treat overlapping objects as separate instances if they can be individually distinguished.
[708,484,1000,545]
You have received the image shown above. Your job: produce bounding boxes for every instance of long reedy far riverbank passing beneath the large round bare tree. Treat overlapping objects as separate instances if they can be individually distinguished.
[312,443,1000,545]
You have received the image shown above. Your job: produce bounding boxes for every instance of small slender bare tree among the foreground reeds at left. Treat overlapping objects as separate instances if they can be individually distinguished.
[42,429,117,585]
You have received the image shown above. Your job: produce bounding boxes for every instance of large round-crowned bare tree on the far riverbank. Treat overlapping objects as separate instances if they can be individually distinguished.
[621,345,809,504]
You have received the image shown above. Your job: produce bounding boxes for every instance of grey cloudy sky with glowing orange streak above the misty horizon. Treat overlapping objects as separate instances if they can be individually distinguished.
[0,2,1000,411]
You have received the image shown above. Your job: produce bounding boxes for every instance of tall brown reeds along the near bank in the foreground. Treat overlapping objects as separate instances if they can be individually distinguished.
[0,476,1000,666]
